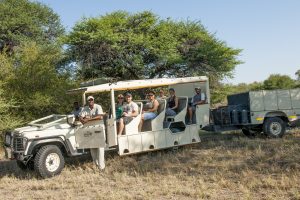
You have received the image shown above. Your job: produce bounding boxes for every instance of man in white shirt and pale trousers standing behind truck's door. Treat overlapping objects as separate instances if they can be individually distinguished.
[79,96,105,170]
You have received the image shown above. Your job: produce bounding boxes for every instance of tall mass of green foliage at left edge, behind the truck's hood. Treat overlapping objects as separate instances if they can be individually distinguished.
[0,0,73,123]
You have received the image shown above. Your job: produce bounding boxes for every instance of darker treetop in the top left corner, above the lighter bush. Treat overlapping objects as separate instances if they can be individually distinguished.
[0,0,64,54]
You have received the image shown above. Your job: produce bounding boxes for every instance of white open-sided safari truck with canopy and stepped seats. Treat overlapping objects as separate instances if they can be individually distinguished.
[5,76,210,178]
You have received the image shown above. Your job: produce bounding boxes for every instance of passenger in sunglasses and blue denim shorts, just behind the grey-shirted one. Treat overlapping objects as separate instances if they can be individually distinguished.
[139,91,159,132]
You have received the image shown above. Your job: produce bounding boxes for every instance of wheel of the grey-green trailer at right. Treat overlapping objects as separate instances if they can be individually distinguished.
[263,117,286,138]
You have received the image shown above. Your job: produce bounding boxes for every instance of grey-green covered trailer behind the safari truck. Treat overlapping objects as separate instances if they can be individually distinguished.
[211,88,300,138]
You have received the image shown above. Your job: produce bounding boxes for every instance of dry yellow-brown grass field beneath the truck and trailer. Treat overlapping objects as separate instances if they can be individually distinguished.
[0,132,300,199]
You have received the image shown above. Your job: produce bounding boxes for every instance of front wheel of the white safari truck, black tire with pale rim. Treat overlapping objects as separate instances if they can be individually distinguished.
[34,145,65,178]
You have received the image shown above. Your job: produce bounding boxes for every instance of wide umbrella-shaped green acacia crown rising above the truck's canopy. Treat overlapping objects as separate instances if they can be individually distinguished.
[64,11,241,80]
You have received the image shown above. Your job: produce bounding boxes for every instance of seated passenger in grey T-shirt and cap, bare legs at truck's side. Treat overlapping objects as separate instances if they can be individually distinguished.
[118,92,139,135]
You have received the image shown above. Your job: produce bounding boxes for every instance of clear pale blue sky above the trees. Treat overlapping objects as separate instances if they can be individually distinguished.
[39,0,300,84]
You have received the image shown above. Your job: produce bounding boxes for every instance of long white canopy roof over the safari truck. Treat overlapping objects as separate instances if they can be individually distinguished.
[68,76,208,94]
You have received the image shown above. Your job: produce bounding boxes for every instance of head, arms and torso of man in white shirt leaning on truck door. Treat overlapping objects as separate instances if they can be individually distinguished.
[79,96,104,124]
